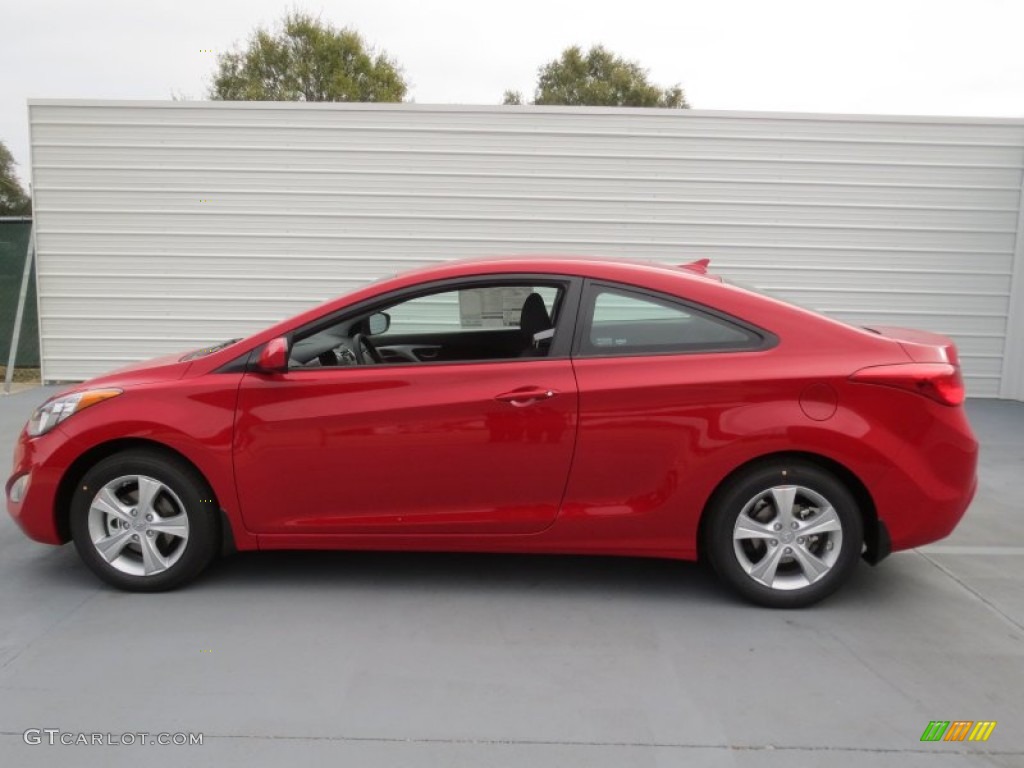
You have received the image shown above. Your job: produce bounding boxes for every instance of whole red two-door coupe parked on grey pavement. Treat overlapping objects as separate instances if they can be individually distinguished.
[6,257,977,607]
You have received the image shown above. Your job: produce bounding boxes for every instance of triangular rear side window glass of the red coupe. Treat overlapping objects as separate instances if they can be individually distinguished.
[580,285,764,356]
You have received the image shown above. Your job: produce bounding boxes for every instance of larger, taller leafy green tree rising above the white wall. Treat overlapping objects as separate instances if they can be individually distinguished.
[209,11,408,101]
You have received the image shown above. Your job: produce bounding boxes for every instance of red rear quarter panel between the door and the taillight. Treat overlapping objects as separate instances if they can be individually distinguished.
[553,345,906,557]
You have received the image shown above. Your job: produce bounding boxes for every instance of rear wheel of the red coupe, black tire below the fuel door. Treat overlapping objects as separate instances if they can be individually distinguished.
[703,462,864,608]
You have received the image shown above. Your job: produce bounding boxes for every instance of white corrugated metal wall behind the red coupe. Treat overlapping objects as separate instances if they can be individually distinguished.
[30,100,1024,398]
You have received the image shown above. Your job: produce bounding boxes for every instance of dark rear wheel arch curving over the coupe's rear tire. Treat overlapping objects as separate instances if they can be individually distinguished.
[697,451,890,565]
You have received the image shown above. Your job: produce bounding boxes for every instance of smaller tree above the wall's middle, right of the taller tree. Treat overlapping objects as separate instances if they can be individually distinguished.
[504,45,689,110]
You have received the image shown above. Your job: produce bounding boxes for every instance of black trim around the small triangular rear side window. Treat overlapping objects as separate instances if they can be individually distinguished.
[572,279,778,359]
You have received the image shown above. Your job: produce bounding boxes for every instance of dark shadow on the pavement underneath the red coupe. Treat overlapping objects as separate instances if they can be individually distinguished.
[19,546,913,612]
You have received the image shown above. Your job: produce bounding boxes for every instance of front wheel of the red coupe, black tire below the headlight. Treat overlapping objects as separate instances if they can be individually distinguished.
[71,450,220,592]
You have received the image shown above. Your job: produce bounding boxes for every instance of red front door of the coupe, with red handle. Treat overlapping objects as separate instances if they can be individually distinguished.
[234,280,578,534]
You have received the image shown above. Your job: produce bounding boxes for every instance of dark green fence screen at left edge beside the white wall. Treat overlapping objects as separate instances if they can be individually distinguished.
[0,218,39,368]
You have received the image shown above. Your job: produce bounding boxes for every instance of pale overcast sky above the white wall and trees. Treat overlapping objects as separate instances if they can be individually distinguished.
[0,0,1024,186]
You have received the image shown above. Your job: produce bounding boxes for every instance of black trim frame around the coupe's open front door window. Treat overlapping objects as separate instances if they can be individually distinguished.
[268,272,584,374]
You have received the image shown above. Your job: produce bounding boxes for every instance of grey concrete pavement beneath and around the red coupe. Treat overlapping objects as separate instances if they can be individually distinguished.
[0,389,1024,768]
